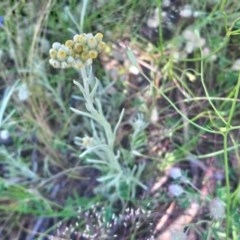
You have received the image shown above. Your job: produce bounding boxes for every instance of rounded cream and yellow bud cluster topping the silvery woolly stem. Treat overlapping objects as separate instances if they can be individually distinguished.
[49,33,106,69]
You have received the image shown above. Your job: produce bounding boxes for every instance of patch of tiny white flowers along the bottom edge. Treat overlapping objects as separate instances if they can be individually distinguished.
[48,204,156,240]
